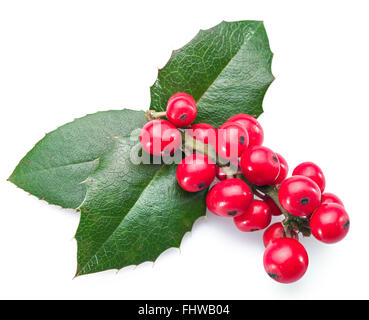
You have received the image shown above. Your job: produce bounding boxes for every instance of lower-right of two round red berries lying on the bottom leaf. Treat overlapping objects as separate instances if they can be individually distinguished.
[177,153,215,192]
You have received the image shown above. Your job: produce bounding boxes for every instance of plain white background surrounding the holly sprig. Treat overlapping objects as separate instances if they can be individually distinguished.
[0,0,369,299]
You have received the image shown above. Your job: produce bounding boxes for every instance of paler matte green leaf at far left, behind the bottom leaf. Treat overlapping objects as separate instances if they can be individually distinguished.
[9,109,146,208]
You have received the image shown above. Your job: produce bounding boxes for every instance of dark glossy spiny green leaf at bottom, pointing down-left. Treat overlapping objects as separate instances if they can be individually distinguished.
[76,139,206,275]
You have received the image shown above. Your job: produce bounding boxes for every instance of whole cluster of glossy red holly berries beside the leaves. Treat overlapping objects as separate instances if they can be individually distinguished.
[140,93,350,283]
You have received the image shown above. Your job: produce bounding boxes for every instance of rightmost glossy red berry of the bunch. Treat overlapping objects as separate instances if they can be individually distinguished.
[310,203,350,243]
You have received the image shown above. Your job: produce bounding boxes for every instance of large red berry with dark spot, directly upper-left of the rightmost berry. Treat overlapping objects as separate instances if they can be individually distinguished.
[278,176,321,217]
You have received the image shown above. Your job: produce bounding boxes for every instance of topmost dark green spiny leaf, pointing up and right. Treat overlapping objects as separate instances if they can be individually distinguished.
[151,21,274,127]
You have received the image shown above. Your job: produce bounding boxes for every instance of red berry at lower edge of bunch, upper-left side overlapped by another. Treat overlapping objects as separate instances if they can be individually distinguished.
[234,200,272,232]
